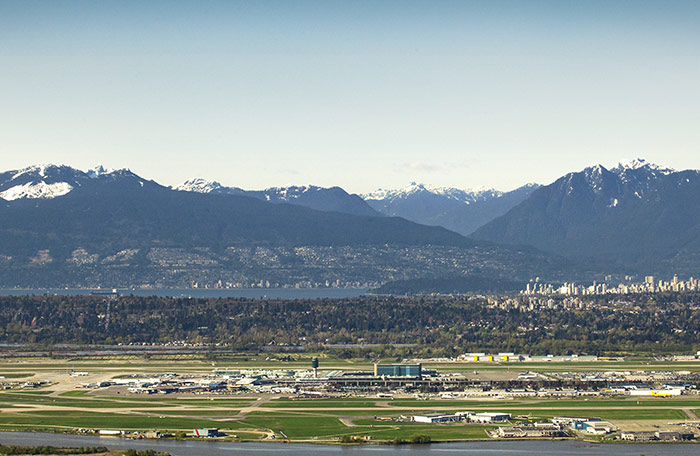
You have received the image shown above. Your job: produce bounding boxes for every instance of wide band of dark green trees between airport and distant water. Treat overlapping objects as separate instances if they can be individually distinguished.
[0,293,700,356]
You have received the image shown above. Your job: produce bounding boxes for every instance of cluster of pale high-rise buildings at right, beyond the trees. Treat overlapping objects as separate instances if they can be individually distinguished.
[521,275,700,296]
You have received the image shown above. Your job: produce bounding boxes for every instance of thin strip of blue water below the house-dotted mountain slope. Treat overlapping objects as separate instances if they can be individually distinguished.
[0,288,368,299]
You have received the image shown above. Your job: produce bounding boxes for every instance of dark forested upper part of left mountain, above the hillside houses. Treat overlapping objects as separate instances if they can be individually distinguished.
[0,166,474,252]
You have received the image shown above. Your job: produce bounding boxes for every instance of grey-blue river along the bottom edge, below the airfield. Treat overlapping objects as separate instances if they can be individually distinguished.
[0,432,700,456]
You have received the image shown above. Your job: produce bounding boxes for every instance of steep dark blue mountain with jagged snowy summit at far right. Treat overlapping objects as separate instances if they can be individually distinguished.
[471,159,700,274]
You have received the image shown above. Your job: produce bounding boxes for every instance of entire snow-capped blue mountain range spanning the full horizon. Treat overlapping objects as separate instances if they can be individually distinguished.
[0,160,700,290]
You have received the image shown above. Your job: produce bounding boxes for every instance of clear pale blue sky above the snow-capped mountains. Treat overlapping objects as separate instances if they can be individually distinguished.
[0,0,700,192]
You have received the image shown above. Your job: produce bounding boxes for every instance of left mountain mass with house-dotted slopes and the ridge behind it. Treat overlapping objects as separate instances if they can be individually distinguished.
[0,165,561,287]
